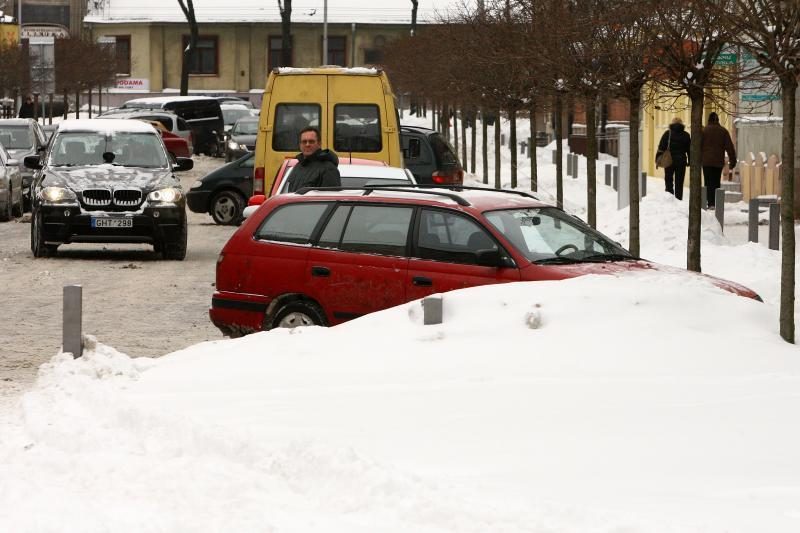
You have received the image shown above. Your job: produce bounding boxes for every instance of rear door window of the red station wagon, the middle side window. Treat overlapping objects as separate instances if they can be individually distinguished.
[318,205,414,256]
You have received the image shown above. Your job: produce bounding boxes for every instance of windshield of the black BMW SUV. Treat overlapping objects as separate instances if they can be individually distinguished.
[50,131,167,168]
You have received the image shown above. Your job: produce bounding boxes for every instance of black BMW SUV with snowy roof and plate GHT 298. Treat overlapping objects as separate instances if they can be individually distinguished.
[25,119,193,261]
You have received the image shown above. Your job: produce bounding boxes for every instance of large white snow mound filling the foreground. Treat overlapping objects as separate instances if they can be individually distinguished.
[0,273,800,533]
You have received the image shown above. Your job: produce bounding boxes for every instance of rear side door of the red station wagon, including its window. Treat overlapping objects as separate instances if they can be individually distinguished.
[306,204,414,324]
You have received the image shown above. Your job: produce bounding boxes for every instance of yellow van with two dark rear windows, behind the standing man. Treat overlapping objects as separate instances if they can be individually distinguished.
[253,67,403,194]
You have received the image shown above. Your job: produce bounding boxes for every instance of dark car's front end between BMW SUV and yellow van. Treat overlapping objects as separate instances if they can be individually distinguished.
[186,152,255,225]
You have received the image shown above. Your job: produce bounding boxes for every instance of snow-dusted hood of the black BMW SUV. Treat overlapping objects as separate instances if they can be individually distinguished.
[42,165,180,191]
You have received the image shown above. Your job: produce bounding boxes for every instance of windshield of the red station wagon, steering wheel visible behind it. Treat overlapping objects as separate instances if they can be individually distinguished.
[485,207,633,263]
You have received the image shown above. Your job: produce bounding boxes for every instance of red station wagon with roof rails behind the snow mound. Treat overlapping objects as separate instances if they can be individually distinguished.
[209,186,759,336]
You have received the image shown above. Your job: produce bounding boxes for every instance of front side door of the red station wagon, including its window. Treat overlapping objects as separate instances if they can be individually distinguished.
[406,208,520,301]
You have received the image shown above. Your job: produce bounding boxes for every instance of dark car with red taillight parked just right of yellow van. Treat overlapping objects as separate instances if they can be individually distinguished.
[400,125,464,185]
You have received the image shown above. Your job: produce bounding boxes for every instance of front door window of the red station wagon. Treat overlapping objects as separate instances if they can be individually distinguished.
[416,209,498,265]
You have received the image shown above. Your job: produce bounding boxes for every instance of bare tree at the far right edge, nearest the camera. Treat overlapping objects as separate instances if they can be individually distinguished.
[723,0,800,343]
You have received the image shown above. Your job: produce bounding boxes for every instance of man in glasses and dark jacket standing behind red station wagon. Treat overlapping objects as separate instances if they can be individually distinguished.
[288,127,342,192]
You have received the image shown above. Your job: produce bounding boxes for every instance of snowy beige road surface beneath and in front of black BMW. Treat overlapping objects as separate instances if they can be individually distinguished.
[0,157,235,401]
